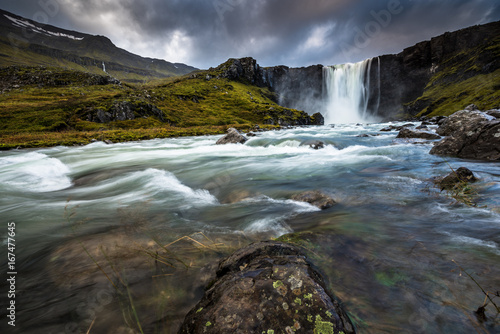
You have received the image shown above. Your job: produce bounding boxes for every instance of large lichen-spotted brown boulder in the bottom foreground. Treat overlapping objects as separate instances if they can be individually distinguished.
[179,241,355,334]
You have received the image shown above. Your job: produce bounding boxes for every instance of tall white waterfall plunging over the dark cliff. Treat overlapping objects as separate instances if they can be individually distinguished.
[323,58,380,124]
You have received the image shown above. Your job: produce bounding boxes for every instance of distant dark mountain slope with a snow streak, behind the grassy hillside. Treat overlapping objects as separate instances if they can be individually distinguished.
[0,10,196,82]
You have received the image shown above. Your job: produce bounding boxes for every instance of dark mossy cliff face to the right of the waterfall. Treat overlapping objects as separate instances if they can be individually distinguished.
[371,22,500,119]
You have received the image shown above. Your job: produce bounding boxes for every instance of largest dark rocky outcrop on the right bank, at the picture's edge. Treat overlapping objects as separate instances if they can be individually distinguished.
[430,110,500,161]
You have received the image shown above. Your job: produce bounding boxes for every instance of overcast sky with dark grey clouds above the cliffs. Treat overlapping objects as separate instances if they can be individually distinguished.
[0,0,500,68]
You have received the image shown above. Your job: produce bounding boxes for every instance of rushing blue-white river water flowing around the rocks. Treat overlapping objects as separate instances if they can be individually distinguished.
[0,124,500,333]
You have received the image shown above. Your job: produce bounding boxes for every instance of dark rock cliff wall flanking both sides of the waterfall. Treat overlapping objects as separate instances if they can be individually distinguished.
[213,22,500,120]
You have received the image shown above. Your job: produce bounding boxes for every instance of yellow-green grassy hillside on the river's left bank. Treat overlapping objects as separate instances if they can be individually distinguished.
[0,66,311,149]
